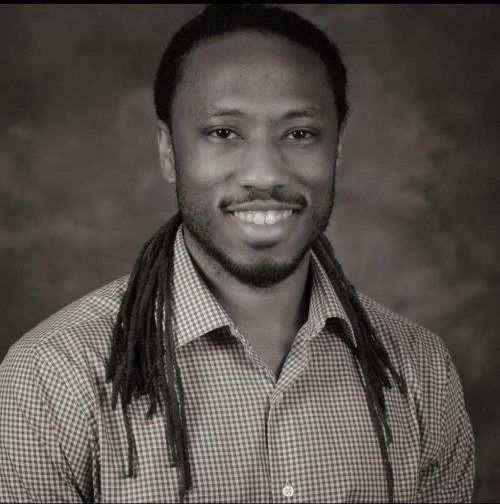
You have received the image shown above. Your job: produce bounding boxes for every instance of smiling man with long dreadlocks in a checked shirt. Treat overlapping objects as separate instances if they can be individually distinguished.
[0,4,474,502]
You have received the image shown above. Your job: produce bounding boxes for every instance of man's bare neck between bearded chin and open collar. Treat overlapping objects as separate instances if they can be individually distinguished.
[184,228,310,344]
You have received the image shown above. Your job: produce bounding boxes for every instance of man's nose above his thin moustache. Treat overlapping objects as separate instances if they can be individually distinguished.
[238,140,289,190]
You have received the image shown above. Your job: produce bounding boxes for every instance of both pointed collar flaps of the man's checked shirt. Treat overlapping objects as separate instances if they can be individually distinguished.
[172,225,355,347]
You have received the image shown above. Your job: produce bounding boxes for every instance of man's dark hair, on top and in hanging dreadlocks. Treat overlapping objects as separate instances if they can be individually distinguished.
[106,4,406,502]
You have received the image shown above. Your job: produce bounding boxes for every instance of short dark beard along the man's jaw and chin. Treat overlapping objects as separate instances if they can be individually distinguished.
[176,173,335,288]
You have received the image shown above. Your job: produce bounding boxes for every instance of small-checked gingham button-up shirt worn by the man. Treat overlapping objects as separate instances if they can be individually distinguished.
[0,226,474,502]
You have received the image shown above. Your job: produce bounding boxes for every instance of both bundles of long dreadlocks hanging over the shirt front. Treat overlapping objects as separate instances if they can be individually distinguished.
[106,214,406,502]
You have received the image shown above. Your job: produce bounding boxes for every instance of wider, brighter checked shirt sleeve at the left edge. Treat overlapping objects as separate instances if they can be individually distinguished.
[0,340,94,502]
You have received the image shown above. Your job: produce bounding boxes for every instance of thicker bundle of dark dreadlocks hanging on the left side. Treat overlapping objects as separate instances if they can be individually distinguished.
[106,214,191,500]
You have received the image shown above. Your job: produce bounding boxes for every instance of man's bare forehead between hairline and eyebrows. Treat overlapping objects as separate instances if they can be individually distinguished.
[173,32,335,121]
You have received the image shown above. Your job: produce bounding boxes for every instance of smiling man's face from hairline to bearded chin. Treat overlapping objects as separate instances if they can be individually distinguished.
[166,32,338,287]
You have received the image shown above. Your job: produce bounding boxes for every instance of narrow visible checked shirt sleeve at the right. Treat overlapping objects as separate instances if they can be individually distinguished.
[417,354,474,502]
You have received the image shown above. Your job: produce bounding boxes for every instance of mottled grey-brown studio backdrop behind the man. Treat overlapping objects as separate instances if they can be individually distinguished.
[0,4,500,502]
